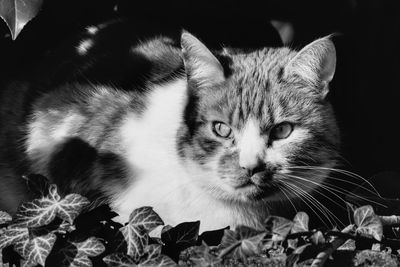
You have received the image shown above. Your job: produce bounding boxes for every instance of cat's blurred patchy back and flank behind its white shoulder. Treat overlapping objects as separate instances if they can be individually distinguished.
[0,19,183,210]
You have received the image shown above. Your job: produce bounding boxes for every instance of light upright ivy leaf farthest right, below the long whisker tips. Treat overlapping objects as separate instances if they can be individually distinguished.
[354,205,383,241]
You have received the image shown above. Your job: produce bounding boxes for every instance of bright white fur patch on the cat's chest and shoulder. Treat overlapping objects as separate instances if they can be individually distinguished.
[112,80,262,231]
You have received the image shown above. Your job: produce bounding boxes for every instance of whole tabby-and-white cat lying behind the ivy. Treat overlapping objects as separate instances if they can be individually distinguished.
[0,22,340,231]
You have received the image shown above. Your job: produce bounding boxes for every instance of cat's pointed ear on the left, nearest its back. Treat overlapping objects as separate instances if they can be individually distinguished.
[181,31,225,86]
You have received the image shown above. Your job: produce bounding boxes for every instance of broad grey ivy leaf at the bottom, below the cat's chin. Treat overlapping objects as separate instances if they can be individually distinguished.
[219,226,266,262]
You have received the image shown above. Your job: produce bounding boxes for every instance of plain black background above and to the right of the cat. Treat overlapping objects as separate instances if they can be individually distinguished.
[0,0,400,197]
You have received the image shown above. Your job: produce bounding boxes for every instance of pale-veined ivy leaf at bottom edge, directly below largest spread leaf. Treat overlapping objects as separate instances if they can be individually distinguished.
[23,233,56,266]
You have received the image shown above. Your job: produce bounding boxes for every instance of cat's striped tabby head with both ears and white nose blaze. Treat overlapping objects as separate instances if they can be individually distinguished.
[177,32,339,202]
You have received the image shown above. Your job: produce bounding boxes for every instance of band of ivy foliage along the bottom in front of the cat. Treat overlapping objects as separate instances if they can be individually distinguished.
[0,176,400,267]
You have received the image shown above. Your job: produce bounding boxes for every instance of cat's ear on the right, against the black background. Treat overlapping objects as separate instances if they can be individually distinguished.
[285,36,336,98]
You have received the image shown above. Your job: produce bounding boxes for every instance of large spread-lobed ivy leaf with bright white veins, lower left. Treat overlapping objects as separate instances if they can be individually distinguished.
[14,185,89,227]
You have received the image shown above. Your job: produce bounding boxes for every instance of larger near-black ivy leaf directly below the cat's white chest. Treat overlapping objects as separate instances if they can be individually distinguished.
[161,221,200,261]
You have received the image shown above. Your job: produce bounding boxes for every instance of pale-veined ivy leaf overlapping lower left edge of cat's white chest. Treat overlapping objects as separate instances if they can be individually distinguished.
[120,207,164,260]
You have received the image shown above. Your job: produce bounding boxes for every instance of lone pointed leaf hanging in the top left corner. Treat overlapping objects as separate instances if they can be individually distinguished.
[0,0,43,40]
